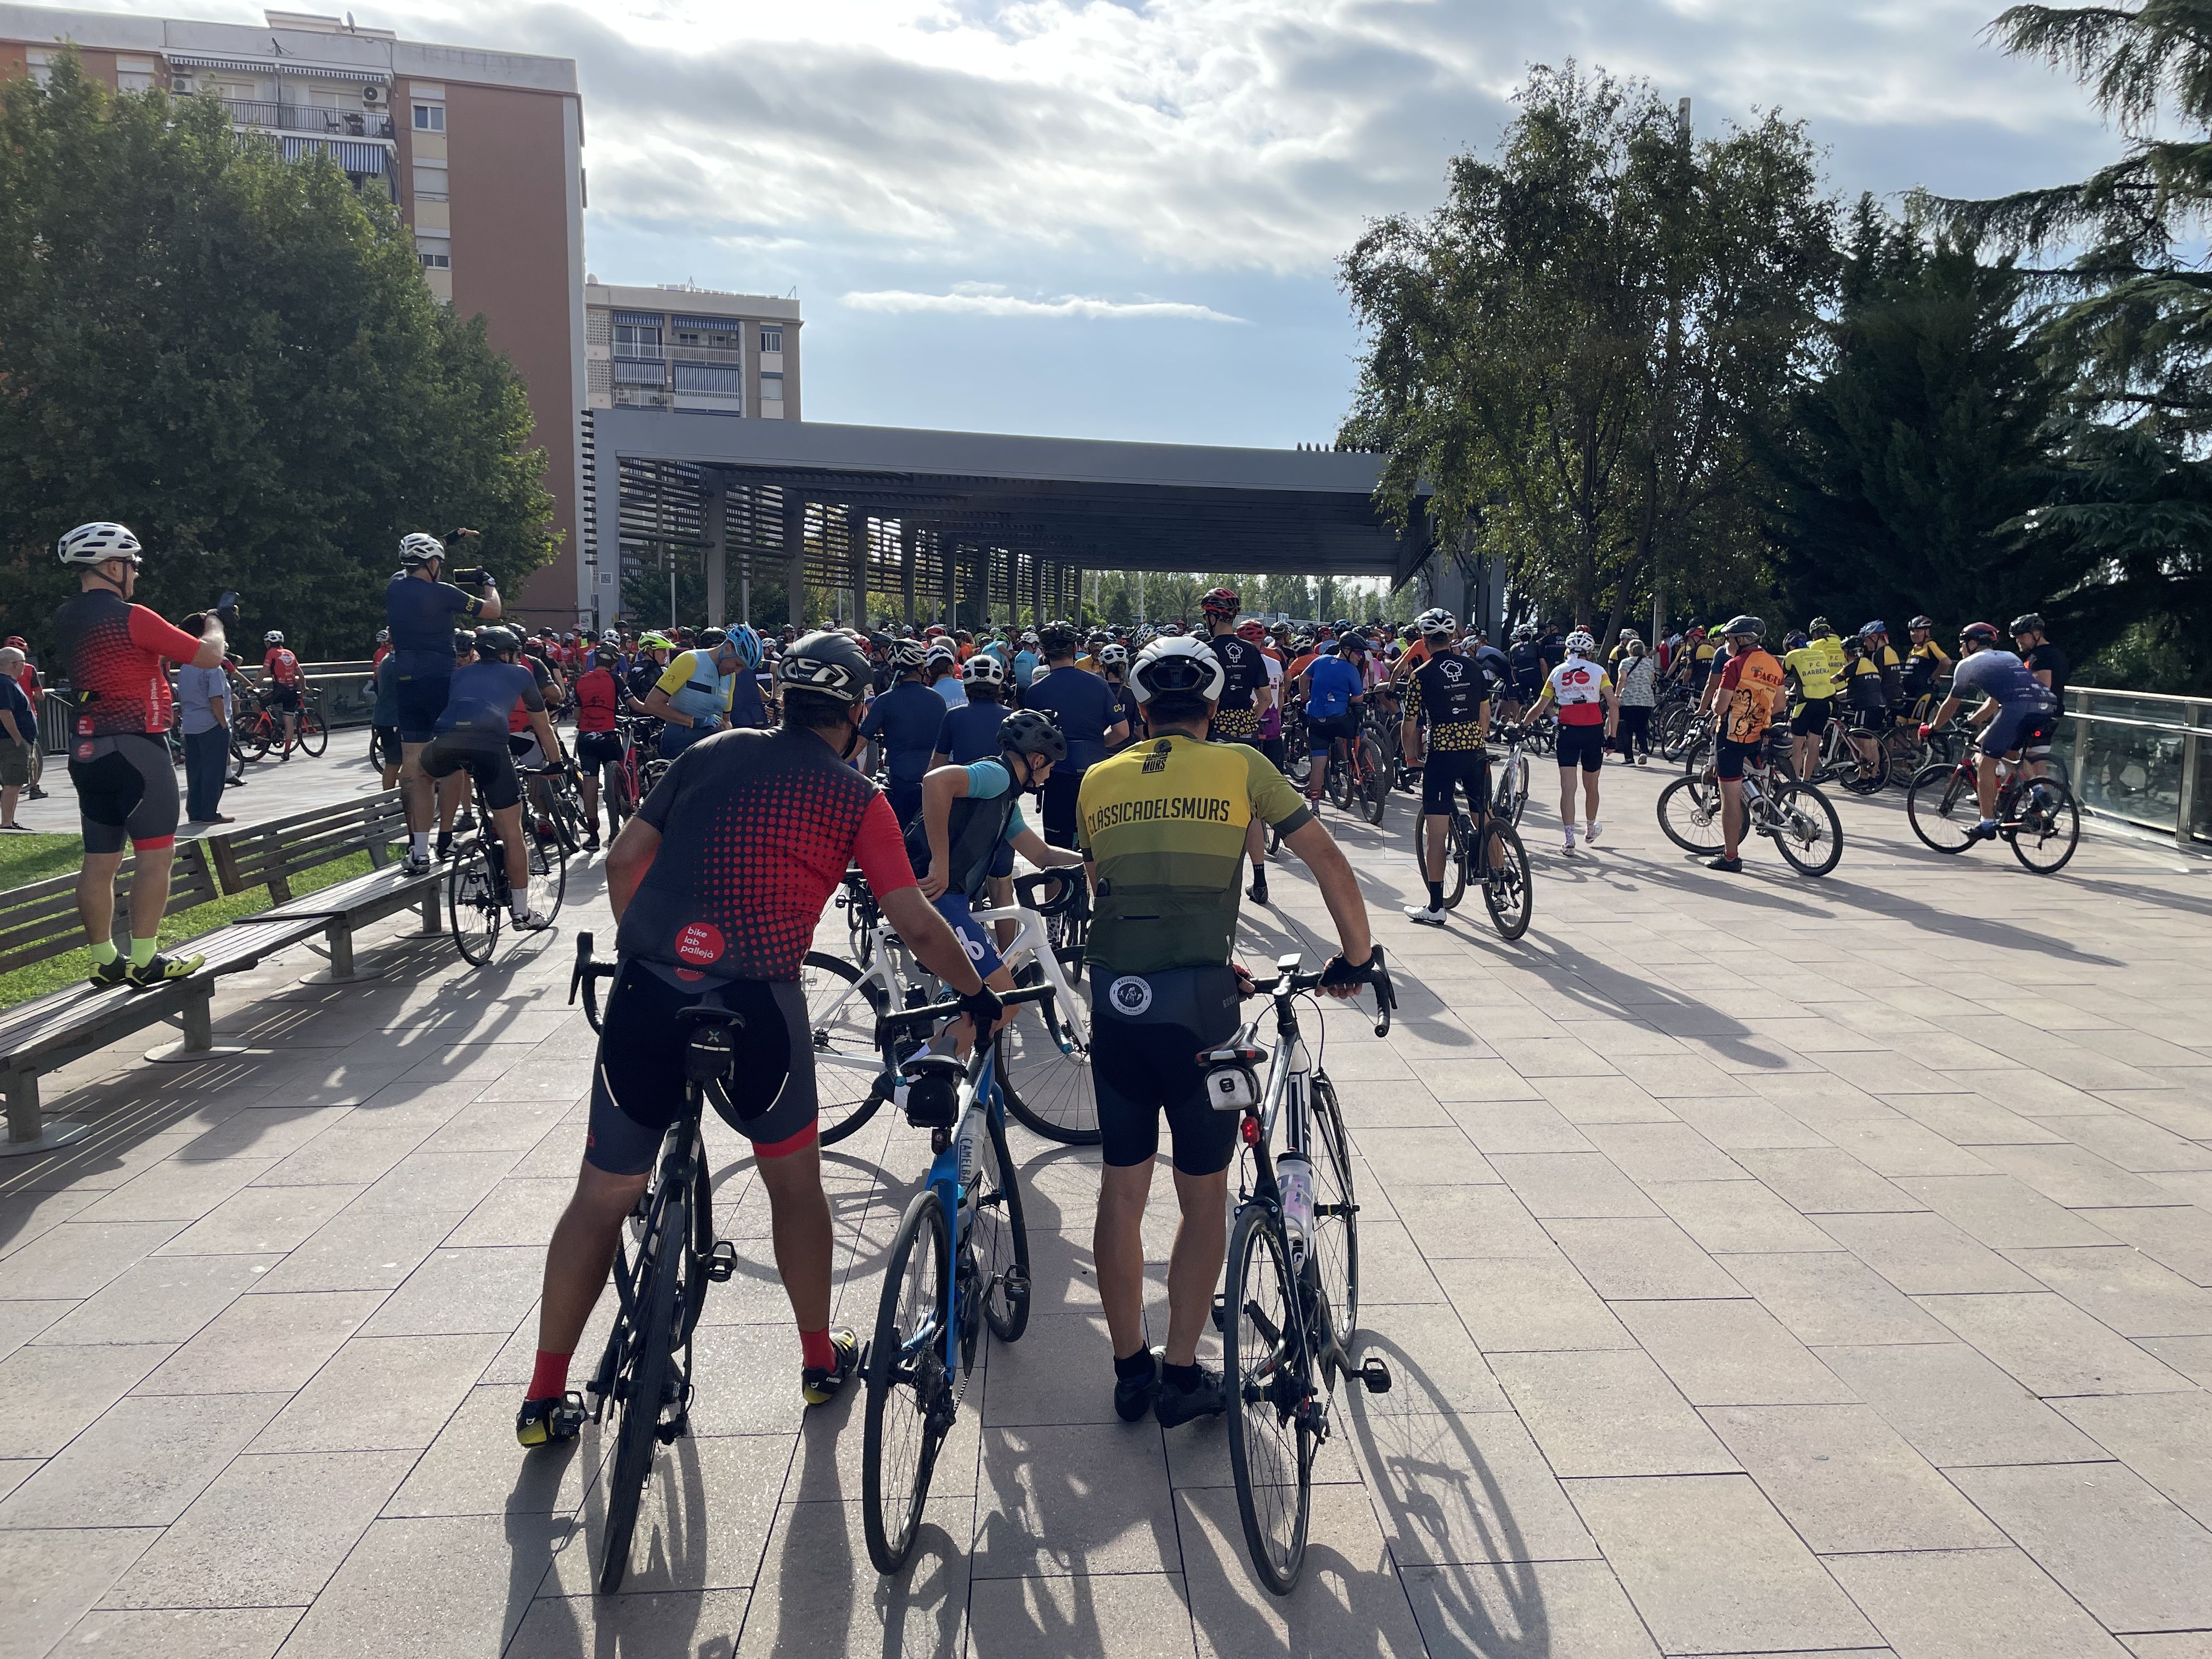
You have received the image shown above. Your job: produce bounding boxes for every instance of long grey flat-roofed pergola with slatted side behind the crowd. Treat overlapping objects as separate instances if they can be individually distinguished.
[582,409,1431,626]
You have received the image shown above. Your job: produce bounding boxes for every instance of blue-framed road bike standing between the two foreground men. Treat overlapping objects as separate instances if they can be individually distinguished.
[860,984,1053,1573]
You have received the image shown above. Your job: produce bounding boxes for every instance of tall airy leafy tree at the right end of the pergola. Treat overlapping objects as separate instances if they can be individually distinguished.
[1340,64,1834,628]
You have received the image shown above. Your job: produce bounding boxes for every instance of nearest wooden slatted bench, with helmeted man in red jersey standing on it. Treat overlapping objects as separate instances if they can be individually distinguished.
[0,840,321,1157]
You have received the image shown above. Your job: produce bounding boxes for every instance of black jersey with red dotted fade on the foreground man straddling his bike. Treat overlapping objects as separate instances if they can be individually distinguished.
[617,730,913,980]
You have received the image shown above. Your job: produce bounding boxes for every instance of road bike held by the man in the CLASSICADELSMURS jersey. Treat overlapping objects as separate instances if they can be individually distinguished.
[1199,947,1398,1595]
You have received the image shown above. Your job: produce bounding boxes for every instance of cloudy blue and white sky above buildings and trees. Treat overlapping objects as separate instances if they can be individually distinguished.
[95,0,2119,447]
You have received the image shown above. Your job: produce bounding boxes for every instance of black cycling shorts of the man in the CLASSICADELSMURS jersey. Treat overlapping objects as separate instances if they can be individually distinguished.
[1091,964,1239,1175]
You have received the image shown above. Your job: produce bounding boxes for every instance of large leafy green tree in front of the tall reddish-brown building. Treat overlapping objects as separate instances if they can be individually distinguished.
[0,55,553,657]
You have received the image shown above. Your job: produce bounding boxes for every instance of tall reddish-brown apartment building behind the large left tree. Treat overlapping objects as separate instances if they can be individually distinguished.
[0,2,593,624]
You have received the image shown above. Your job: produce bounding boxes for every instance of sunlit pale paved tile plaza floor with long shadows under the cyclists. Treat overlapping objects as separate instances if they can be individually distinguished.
[0,770,2212,1659]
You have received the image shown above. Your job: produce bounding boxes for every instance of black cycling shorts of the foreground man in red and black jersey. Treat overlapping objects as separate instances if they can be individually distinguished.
[584,958,819,1175]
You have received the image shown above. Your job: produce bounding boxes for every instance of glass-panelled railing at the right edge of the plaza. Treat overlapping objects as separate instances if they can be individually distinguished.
[2051,686,2212,845]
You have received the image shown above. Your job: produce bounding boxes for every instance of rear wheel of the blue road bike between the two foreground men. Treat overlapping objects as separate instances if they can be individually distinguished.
[860,1188,958,1573]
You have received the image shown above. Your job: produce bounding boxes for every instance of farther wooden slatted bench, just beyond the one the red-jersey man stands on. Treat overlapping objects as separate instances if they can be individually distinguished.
[208,789,444,984]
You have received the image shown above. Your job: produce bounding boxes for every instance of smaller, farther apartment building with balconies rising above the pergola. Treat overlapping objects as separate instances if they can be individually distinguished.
[584,276,799,420]
